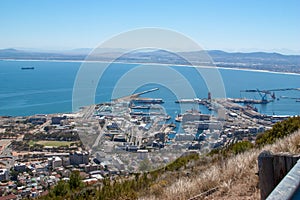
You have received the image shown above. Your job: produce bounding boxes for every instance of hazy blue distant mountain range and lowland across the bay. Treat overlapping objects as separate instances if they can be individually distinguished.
[0,48,300,73]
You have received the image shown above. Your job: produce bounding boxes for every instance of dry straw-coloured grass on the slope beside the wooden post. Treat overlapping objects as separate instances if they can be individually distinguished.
[141,131,300,200]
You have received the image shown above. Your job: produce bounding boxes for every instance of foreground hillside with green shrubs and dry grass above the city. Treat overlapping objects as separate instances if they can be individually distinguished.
[40,117,300,200]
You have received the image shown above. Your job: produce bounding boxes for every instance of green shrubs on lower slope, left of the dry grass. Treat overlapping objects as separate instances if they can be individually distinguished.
[41,153,199,200]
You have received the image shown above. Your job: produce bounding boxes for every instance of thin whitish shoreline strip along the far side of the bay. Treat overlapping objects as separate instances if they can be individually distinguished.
[0,59,300,76]
